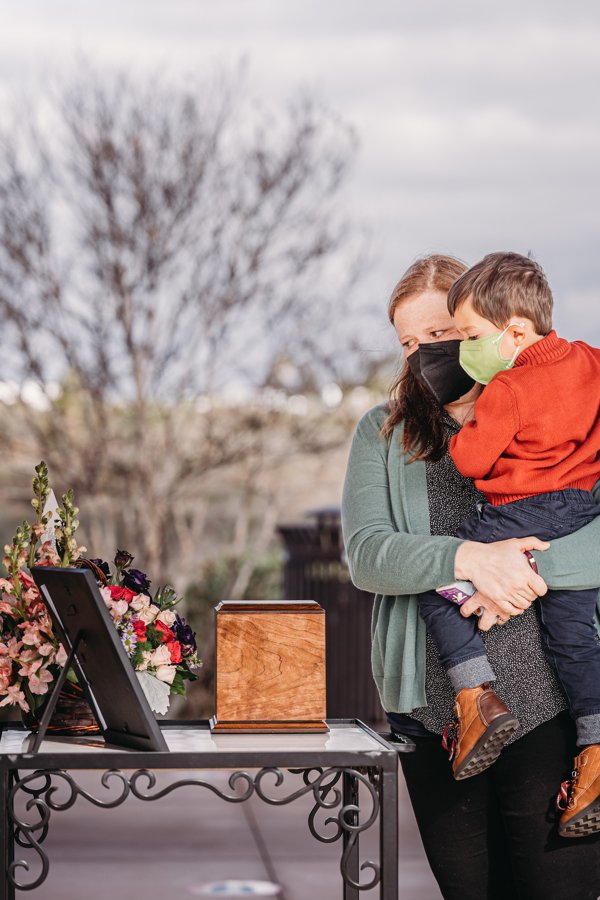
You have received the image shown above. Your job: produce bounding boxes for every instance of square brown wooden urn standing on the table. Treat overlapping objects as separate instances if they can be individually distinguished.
[210,600,329,733]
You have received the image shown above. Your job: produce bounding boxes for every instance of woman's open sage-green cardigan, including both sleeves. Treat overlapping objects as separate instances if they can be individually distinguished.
[342,405,600,712]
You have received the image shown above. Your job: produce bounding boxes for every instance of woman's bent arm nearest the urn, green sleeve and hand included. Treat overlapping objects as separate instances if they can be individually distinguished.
[342,413,546,616]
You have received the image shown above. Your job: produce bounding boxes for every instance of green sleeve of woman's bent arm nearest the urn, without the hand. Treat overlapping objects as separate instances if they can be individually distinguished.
[342,414,462,595]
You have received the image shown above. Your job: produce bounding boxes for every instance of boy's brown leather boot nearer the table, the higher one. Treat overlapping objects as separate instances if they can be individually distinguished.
[442,682,519,781]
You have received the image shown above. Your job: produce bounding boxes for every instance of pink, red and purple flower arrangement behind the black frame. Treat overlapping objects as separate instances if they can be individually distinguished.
[0,462,201,731]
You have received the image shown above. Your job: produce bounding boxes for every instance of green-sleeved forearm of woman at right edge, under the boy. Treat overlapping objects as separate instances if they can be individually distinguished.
[534,481,600,591]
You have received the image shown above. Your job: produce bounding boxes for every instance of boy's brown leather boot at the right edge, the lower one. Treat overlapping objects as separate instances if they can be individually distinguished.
[556,744,600,837]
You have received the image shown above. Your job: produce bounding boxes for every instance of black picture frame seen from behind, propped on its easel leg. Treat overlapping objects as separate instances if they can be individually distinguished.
[31,566,169,751]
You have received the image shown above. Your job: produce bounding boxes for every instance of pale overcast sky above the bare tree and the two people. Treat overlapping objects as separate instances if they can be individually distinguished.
[0,0,600,354]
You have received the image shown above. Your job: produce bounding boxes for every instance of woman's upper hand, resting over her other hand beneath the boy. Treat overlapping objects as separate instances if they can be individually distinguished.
[454,537,550,618]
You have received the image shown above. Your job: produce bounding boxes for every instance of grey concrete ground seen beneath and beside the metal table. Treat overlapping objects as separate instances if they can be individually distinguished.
[12,772,441,900]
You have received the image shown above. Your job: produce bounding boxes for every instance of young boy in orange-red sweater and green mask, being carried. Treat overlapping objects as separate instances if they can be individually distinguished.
[419,253,600,837]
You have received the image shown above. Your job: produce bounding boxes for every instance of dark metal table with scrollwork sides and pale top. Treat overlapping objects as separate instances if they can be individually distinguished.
[0,719,410,900]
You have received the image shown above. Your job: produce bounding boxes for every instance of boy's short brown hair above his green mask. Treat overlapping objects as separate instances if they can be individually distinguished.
[448,253,553,335]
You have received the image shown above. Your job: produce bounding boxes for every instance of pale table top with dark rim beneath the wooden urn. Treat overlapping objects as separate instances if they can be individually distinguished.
[0,719,404,769]
